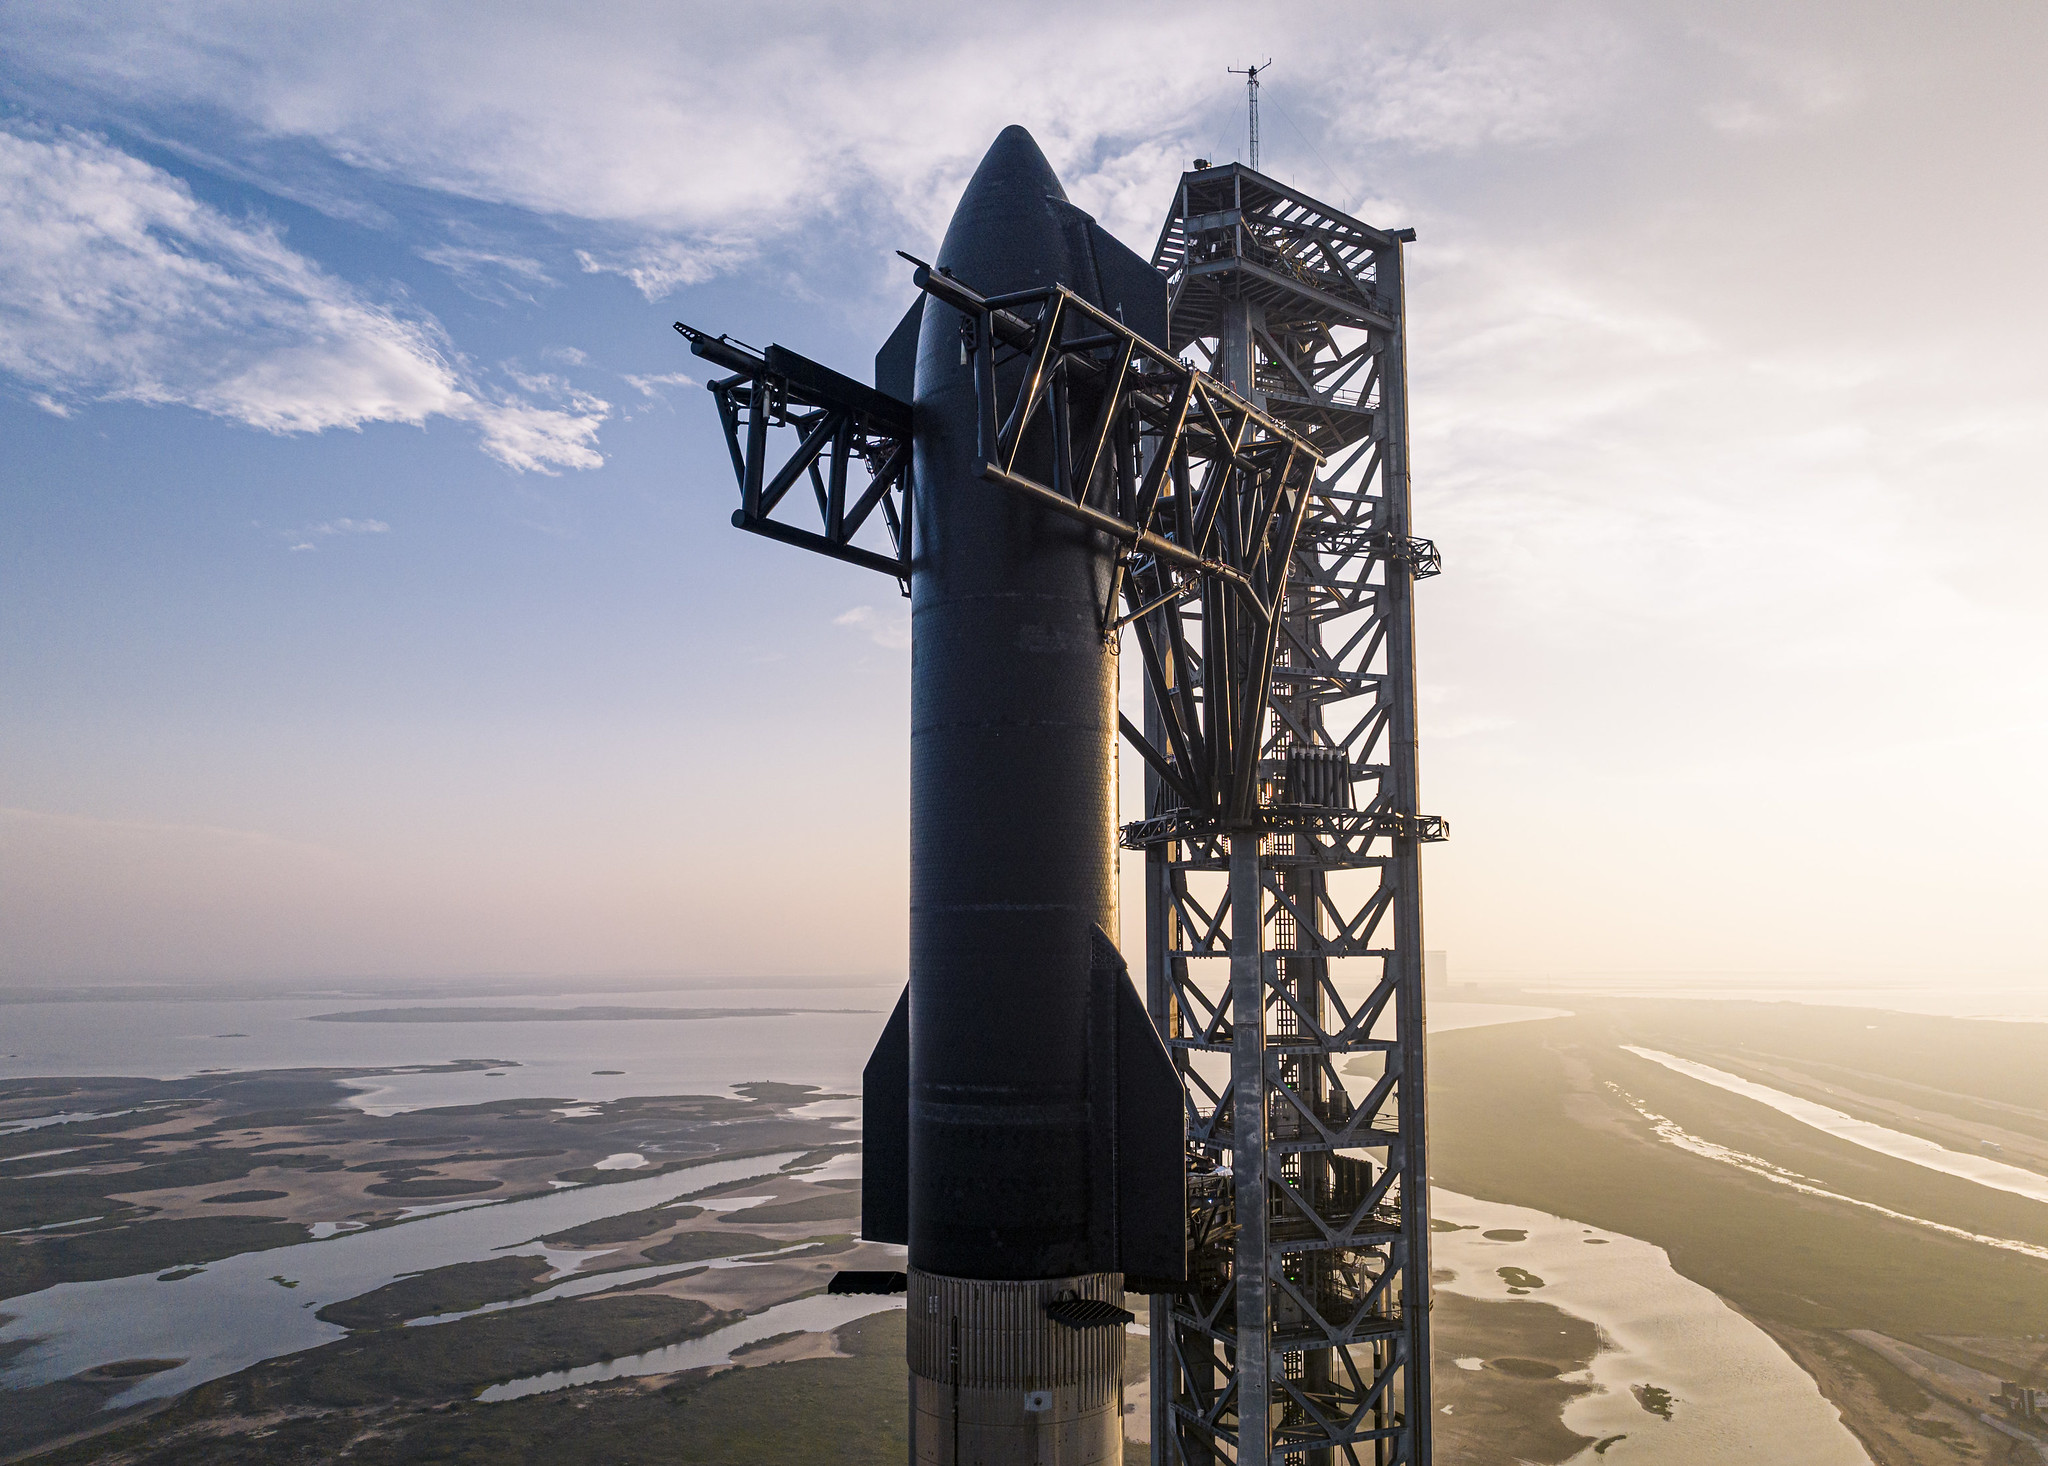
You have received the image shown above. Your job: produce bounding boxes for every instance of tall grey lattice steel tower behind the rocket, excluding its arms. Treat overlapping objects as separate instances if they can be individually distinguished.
[1124,164,1444,1466]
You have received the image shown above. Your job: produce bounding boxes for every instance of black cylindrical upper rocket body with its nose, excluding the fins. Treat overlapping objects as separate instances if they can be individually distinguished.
[909,129,1116,1278]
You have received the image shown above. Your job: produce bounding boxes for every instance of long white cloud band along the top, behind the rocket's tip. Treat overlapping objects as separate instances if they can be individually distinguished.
[0,0,1649,286]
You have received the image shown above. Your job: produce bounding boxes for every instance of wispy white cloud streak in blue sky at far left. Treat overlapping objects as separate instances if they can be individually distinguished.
[0,129,606,473]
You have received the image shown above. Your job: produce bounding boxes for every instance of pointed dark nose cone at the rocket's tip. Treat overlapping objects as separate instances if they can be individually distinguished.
[938,127,1071,295]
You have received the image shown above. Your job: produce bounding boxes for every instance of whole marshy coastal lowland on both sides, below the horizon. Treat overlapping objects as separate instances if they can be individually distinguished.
[0,993,2048,1466]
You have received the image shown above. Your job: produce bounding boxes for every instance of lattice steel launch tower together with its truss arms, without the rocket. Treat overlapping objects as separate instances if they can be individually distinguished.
[678,164,1446,1466]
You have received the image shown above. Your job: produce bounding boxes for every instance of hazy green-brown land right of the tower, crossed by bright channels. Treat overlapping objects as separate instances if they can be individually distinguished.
[1430,995,2048,1466]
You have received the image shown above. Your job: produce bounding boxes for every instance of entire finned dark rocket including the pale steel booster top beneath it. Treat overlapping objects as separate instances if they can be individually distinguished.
[862,127,1186,1466]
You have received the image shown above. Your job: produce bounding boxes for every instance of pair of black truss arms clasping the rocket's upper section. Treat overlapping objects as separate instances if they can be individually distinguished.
[676,264,1323,825]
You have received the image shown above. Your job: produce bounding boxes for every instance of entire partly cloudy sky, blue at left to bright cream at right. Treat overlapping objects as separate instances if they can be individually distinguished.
[0,0,2048,985]
